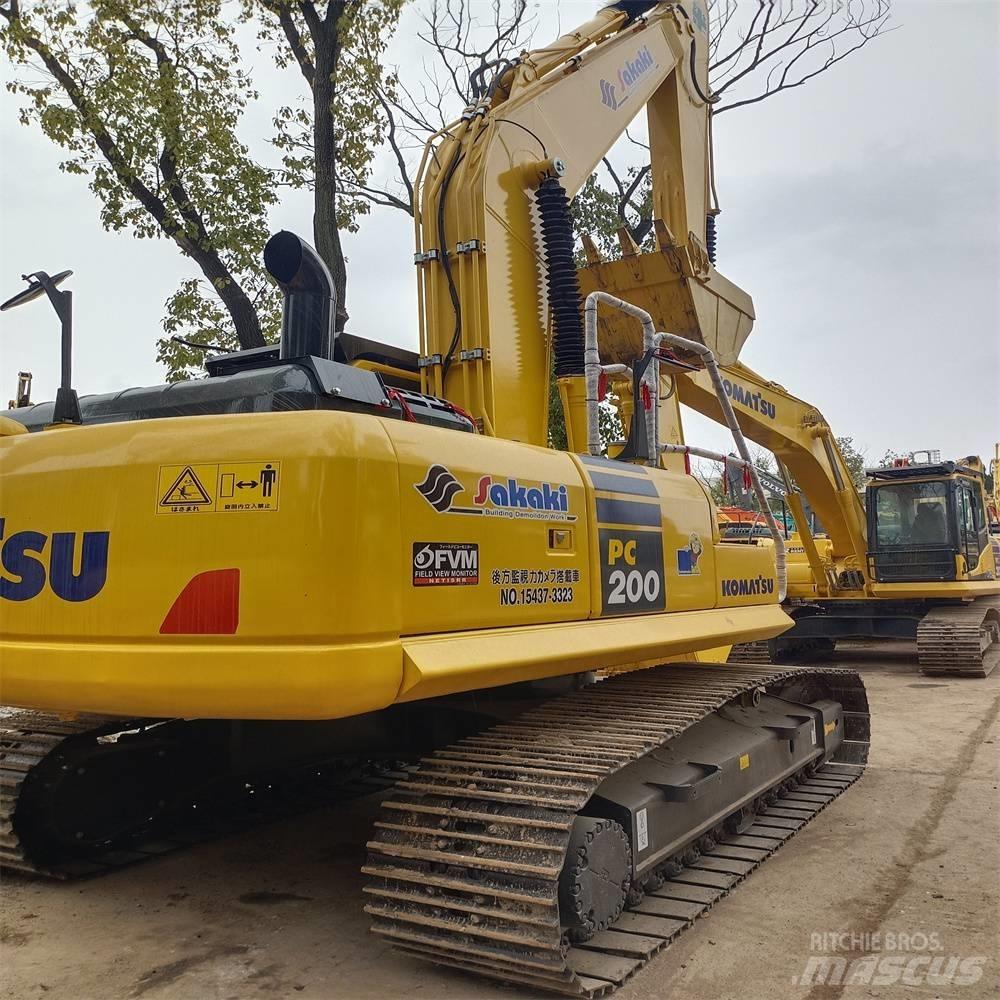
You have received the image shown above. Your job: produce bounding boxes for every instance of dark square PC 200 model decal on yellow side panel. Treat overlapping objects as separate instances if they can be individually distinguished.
[598,528,667,615]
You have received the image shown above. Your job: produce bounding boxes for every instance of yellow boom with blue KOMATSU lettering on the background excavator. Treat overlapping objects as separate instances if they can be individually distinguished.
[675,362,868,596]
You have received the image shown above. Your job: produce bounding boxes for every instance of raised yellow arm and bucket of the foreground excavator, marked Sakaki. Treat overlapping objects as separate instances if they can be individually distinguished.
[415,0,753,450]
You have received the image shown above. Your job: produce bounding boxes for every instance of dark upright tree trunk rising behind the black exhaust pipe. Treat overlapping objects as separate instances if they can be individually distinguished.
[313,19,347,333]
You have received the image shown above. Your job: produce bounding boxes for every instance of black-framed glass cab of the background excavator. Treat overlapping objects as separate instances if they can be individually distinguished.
[866,462,996,583]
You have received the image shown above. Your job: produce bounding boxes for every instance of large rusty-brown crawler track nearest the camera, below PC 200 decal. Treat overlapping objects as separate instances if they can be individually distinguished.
[364,664,869,997]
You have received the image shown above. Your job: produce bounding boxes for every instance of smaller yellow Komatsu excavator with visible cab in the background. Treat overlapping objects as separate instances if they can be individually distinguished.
[640,363,1000,677]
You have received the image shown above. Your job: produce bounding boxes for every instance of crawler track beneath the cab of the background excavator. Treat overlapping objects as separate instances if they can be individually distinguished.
[917,597,1000,677]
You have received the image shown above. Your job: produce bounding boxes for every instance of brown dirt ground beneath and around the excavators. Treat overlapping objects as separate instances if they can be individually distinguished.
[0,644,1000,1000]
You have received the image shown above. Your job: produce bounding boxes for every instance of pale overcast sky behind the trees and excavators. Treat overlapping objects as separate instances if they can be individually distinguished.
[0,0,1000,461]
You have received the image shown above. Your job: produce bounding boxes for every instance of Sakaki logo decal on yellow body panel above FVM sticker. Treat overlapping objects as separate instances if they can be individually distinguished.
[414,465,576,521]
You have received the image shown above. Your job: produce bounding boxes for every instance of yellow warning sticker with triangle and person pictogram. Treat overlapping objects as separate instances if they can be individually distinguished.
[156,461,281,514]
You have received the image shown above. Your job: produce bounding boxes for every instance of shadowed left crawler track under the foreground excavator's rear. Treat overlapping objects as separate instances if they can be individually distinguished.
[0,712,405,879]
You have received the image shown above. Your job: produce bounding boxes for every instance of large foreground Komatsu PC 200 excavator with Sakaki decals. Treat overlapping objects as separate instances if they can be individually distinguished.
[0,0,869,996]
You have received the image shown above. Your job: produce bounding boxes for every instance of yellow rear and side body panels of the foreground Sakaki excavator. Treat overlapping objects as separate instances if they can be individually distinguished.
[0,411,789,719]
